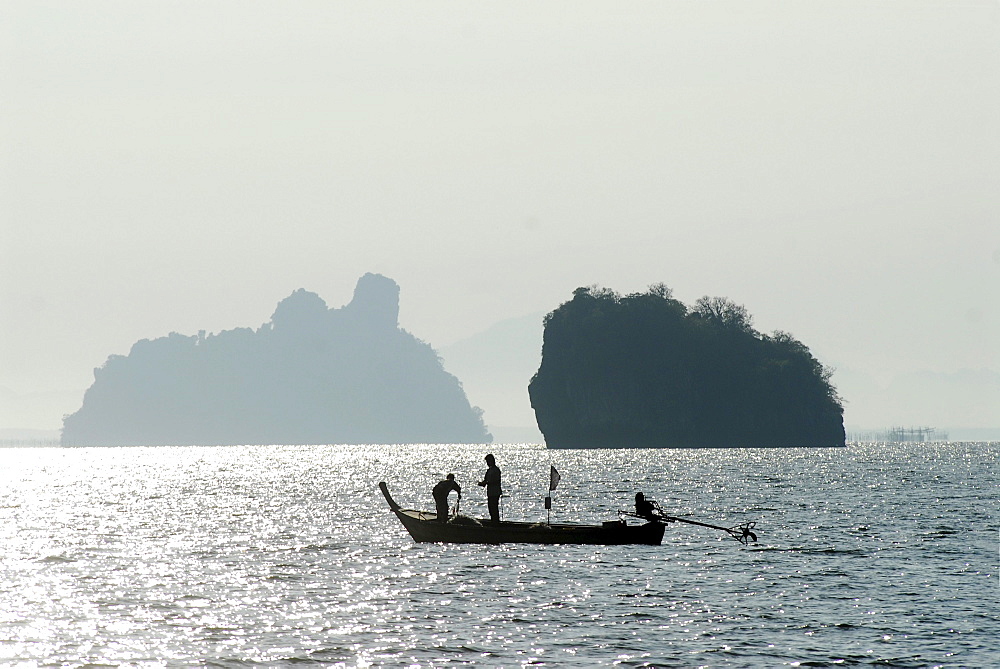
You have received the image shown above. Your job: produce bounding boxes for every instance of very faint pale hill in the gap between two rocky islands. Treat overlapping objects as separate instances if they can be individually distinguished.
[438,313,545,443]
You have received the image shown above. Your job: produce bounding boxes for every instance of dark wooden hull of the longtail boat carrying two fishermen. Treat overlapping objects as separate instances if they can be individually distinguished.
[378,481,664,546]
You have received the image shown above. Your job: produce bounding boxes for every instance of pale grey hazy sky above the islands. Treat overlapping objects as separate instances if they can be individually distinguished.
[0,0,1000,428]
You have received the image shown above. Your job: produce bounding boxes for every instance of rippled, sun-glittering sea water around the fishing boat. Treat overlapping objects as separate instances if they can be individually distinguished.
[0,443,1000,667]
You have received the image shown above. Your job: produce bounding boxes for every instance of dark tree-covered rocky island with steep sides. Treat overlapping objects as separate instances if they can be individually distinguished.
[528,284,845,448]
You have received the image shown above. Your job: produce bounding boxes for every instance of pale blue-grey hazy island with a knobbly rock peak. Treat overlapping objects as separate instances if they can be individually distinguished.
[62,274,491,446]
